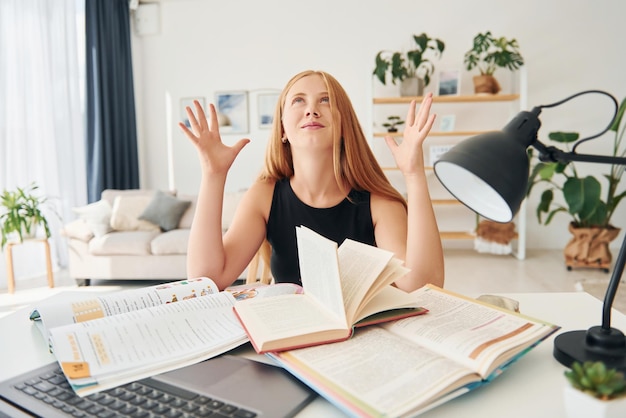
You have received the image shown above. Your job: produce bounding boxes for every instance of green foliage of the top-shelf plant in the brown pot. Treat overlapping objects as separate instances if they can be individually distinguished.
[464,31,524,75]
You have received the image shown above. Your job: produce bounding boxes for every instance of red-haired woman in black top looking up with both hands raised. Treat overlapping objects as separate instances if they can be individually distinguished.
[179,71,444,291]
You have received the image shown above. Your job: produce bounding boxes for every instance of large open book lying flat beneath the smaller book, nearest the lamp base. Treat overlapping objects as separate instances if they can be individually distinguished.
[268,285,559,417]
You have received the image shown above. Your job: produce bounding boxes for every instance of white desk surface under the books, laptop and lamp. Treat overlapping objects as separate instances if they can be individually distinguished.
[0,293,626,418]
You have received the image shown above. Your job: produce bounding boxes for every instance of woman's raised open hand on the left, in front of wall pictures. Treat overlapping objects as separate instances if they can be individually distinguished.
[178,100,250,174]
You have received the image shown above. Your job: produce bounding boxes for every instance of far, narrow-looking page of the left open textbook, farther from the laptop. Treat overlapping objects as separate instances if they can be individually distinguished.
[30,277,219,338]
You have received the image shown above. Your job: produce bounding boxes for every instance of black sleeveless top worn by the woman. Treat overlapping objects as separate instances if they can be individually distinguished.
[267,178,375,285]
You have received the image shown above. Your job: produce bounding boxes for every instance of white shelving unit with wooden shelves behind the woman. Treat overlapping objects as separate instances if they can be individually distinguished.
[371,71,527,260]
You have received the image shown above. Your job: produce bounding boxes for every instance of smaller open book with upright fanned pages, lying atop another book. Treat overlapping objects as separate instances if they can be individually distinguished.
[235,227,426,353]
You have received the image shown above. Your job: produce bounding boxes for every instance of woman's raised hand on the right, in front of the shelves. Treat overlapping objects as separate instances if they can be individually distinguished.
[385,93,435,176]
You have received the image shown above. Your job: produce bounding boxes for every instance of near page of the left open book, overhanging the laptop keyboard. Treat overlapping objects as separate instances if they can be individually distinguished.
[50,292,248,393]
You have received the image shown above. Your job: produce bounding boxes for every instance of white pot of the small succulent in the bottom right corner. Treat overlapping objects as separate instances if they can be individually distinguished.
[563,385,626,418]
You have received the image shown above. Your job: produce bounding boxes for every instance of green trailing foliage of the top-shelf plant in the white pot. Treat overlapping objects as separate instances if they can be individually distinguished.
[373,33,445,86]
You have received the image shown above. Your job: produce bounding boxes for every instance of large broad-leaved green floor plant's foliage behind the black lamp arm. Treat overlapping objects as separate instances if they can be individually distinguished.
[526,98,626,228]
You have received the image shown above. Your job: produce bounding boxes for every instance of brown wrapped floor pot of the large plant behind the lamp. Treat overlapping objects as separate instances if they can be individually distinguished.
[563,223,620,272]
